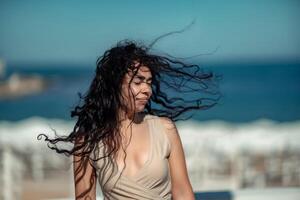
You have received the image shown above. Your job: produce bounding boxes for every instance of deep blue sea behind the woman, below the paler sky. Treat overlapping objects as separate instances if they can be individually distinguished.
[0,62,300,123]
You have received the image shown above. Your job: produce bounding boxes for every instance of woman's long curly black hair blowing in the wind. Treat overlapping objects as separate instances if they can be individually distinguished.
[38,29,222,197]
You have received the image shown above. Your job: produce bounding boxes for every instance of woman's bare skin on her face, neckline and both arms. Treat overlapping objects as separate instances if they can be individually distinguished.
[74,63,195,200]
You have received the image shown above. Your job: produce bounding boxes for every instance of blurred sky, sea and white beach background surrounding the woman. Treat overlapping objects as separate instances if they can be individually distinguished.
[0,0,300,200]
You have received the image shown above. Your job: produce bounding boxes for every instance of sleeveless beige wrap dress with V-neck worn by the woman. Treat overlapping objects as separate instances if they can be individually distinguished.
[91,114,172,200]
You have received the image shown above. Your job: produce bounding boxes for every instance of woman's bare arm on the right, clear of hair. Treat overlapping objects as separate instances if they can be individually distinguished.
[161,117,195,200]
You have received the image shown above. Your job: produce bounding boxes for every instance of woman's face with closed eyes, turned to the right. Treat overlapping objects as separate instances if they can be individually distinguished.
[122,64,152,113]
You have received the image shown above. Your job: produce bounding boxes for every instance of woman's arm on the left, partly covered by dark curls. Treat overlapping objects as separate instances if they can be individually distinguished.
[73,137,96,200]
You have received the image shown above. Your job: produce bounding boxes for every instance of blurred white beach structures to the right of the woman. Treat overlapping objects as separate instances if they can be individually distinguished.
[178,120,300,191]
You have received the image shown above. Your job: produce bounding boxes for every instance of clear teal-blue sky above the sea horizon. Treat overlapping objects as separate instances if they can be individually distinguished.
[0,0,300,63]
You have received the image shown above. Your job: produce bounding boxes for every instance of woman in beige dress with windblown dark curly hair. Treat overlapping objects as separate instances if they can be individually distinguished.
[38,38,218,200]
